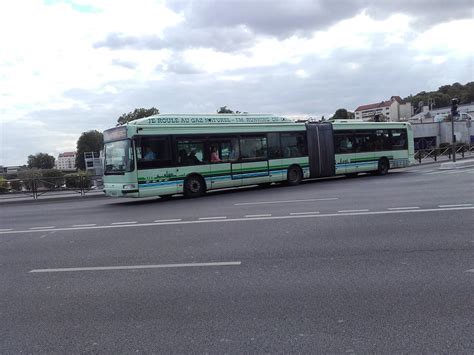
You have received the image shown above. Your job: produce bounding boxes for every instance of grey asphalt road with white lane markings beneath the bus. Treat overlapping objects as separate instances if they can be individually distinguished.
[0,165,474,354]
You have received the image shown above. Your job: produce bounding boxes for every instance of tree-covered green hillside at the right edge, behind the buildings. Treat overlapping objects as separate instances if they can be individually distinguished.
[404,81,474,111]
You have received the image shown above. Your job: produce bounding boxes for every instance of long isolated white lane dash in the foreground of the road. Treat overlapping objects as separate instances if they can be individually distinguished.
[30,261,242,273]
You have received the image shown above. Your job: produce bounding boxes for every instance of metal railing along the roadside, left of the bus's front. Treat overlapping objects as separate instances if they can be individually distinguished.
[0,175,103,200]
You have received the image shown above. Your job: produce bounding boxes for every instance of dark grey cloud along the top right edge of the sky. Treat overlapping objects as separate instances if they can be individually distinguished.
[167,0,474,38]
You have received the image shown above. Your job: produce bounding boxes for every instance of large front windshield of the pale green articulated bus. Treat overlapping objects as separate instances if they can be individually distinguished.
[104,139,134,175]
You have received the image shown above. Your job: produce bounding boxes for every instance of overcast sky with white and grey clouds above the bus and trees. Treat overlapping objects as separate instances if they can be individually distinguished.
[0,0,474,165]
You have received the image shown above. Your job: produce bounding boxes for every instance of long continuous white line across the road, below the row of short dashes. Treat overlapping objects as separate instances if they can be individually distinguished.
[0,206,474,234]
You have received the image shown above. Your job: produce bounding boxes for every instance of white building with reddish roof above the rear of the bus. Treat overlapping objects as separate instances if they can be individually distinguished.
[355,96,413,121]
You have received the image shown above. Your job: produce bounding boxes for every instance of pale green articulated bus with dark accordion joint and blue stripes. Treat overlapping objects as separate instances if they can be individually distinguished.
[104,114,414,197]
